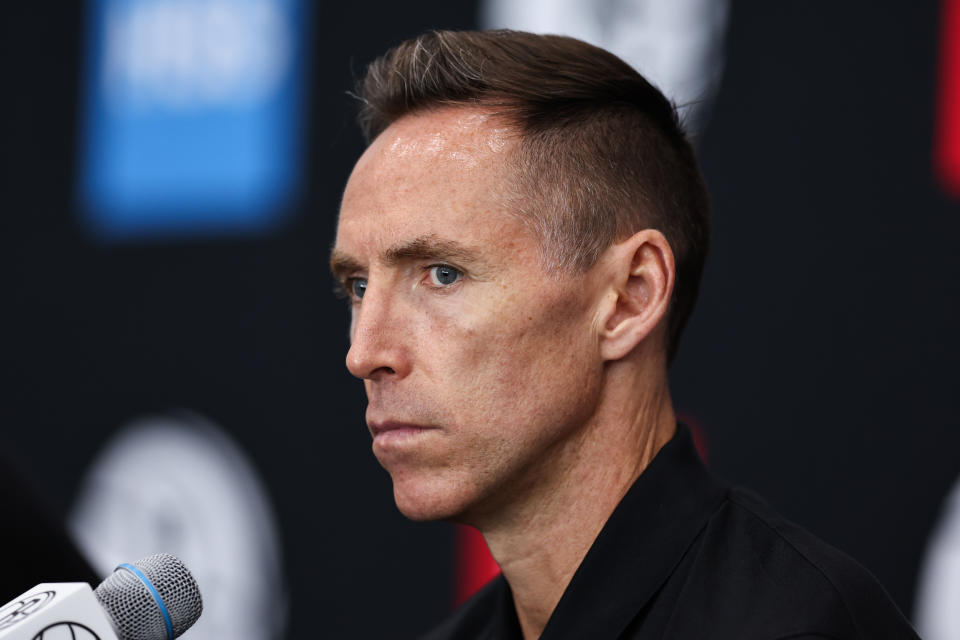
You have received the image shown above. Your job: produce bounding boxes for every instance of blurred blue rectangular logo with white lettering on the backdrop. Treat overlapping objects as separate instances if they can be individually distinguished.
[79,0,305,239]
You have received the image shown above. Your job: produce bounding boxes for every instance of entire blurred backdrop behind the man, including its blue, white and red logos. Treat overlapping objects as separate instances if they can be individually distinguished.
[0,0,960,640]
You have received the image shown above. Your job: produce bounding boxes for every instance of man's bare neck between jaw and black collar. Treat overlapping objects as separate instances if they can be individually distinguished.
[479,363,676,640]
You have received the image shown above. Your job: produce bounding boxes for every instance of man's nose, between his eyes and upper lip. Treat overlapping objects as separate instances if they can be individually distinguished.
[347,286,410,380]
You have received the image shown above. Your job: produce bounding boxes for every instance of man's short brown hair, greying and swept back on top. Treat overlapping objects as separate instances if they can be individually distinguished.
[357,30,709,360]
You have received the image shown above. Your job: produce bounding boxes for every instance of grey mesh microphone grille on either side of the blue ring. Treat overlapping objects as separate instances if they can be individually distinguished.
[95,553,203,640]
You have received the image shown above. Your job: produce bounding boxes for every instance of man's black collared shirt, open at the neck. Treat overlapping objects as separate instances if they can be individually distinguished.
[426,425,917,640]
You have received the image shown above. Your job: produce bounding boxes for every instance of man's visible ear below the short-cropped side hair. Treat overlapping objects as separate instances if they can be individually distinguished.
[599,229,675,360]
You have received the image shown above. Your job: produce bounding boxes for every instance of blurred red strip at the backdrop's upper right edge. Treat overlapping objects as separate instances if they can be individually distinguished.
[933,0,960,197]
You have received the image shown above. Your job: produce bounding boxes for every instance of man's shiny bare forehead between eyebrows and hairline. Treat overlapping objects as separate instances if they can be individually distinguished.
[337,107,519,254]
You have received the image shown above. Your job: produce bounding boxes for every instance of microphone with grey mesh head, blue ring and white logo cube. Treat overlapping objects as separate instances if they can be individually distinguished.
[0,553,203,640]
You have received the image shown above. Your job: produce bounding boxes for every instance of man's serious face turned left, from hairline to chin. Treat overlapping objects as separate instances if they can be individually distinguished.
[332,107,603,522]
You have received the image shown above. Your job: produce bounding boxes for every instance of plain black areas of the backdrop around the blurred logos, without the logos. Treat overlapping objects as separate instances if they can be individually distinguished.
[0,0,960,638]
